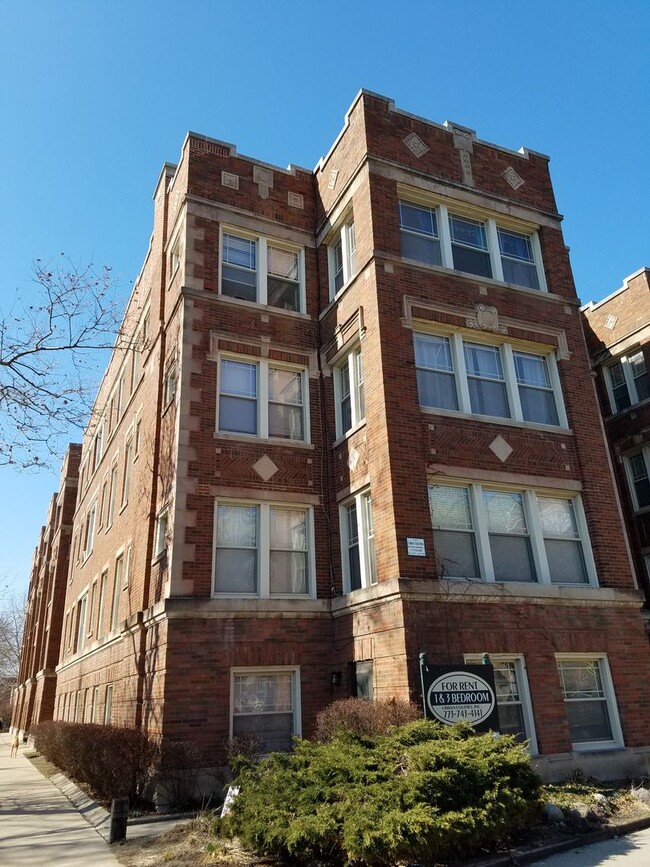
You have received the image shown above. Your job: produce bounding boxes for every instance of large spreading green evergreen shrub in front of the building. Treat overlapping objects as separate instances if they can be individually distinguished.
[221,720,539,865]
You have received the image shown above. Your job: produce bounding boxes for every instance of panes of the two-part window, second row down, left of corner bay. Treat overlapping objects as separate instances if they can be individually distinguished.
[218,358,308,442]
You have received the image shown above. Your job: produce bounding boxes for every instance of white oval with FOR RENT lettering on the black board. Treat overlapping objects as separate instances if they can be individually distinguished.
[426,666,498,727]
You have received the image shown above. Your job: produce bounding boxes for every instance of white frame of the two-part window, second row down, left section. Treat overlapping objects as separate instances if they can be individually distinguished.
[216,353,311,444]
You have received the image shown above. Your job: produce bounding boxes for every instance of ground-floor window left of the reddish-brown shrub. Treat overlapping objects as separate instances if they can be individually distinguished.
[231,669,301,753]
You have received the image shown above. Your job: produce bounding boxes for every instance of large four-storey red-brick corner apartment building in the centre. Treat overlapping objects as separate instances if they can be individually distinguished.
[14,92,650,777]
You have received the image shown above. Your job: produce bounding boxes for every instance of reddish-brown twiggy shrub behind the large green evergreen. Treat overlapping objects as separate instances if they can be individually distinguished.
[315,698,422,741]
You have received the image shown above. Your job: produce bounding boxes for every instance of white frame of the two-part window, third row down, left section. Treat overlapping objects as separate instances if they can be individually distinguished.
[212,498,316,599]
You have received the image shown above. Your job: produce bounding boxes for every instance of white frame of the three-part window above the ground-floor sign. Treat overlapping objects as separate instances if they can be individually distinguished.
[428,476,599,587]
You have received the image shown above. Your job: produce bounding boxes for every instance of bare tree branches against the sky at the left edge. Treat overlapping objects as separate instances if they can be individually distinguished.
[0,258,124,468]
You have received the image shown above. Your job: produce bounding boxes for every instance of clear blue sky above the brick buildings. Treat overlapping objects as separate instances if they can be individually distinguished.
[0,0,650,589]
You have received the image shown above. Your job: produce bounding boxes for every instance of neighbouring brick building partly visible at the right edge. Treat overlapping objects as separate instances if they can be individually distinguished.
[582,268,650,608]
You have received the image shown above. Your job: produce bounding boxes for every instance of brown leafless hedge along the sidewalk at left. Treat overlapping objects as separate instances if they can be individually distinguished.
[32,722,159,805]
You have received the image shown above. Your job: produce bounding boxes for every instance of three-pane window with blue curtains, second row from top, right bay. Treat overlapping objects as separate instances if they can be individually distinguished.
[413,333,568,427]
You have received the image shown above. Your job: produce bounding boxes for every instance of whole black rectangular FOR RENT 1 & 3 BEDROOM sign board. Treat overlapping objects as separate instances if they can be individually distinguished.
[420,656,499,732]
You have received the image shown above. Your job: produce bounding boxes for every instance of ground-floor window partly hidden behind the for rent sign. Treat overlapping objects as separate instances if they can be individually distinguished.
[465,654,537,755]
